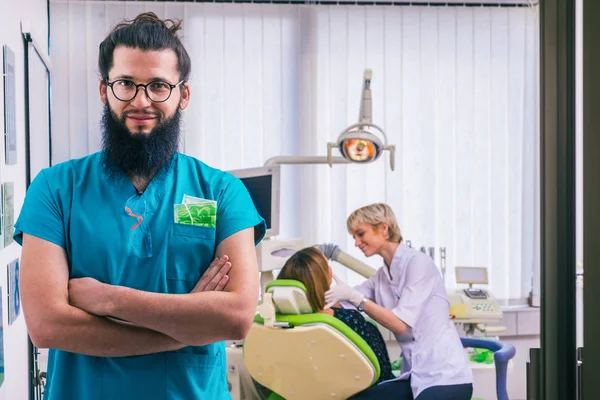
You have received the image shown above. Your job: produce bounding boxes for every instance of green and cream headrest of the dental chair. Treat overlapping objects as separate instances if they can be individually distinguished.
[265,279,315,315]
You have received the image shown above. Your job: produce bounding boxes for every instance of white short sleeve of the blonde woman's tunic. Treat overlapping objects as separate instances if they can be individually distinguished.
[392,257,437,328]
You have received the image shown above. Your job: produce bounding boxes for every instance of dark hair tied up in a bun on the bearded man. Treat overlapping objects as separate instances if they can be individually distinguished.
[98,12,192,81]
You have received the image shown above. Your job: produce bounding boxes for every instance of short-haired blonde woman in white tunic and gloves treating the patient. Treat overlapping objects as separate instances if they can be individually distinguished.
[325,203,473,400]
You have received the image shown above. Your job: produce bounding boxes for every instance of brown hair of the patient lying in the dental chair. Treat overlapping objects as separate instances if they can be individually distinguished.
[277,247,331,311]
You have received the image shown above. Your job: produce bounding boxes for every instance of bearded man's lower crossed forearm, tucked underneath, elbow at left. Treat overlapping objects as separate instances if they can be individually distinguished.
[28,305,185,357]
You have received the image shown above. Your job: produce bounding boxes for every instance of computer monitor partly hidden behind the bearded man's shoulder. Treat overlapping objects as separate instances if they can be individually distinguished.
[229,165,280,237]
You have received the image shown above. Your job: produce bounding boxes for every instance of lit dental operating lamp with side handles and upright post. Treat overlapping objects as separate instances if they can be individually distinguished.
[327,69,396,171]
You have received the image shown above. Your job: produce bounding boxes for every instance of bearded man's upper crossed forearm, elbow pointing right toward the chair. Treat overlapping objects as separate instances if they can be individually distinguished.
[109,286,256,346]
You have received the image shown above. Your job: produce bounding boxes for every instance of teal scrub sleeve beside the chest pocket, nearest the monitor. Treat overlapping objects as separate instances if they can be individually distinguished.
[216,175,267,245]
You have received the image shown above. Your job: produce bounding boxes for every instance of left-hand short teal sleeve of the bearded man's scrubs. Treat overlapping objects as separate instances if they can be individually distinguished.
[13,170,66,249]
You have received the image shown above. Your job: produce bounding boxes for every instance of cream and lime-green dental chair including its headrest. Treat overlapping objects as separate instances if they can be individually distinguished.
[244,280,380,400]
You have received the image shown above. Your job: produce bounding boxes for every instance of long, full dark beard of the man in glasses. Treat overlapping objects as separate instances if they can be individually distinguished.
[101,104,181,180]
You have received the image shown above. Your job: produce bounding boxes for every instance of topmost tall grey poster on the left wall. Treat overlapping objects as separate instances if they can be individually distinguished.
[4,45,17,165]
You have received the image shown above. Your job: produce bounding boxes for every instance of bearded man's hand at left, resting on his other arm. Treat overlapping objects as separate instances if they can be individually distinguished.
[69,278,111,317]
